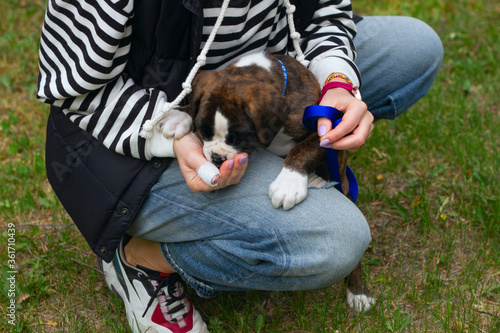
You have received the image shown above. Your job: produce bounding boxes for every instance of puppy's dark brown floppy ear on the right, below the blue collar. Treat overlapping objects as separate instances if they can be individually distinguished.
[247,96,290,147]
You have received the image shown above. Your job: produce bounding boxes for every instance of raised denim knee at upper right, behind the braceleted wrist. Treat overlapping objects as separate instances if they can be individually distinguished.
[354,16,443,119]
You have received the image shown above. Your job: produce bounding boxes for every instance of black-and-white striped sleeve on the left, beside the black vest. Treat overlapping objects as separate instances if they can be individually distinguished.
[37,0,174,160]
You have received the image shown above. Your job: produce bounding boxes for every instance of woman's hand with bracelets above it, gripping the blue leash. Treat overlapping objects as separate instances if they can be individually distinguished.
[318,88,374,152]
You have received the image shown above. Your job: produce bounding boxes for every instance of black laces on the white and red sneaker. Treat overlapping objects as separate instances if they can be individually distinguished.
[142,274,189,321]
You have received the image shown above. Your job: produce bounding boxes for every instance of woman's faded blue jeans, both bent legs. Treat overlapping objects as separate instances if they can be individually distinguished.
[128,17,442,297]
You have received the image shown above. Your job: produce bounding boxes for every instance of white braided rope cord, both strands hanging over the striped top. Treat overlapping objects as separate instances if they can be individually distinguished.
[139,0,307,139]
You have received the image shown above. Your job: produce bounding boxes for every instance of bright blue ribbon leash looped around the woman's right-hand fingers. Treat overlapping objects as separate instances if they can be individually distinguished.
[302,105,358,202]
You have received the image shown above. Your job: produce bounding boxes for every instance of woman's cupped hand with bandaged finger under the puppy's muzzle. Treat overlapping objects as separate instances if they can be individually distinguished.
[174,133,248,193]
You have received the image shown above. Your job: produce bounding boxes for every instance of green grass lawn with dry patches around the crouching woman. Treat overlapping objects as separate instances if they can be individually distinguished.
[0,0,500,333]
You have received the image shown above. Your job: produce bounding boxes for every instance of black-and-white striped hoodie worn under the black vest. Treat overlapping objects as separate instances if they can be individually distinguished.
[37,0,360,160]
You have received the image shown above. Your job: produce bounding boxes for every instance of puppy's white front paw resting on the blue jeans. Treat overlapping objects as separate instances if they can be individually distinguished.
[269,168,307,210]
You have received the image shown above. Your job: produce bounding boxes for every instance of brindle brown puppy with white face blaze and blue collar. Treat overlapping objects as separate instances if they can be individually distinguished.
[184,53,373,311]
